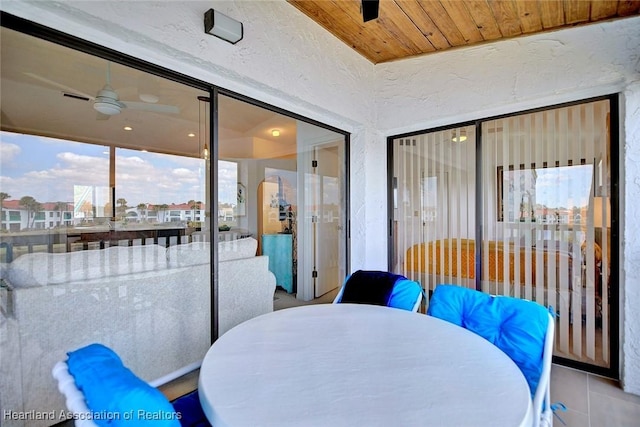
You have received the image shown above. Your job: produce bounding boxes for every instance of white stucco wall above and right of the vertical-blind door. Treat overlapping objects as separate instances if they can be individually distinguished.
[373,17,640,394]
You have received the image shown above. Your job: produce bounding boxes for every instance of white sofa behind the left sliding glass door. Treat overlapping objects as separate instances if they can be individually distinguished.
[0,238,276,426]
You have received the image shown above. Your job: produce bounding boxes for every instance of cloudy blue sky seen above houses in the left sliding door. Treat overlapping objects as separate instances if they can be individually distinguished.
[0,132,236,206]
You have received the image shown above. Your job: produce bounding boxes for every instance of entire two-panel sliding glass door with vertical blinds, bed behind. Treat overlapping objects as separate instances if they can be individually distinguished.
[389,98,618,375]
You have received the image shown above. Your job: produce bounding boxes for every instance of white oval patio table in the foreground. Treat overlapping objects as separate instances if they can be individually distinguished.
[199,304,532,427]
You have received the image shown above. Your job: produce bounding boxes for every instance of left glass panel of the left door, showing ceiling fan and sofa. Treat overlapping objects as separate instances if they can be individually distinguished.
[0,22,213,426]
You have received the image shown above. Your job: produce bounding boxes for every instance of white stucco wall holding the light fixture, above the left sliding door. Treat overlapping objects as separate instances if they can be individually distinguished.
[0,0,378,268]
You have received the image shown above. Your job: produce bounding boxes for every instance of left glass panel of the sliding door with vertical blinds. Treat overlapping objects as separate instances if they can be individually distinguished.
[393,126,476,293]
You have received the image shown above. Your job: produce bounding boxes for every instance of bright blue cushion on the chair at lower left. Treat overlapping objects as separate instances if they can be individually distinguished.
[67,344,180,427]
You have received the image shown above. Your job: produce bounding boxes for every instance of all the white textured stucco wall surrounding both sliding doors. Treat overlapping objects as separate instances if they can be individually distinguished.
[0,0,640,394]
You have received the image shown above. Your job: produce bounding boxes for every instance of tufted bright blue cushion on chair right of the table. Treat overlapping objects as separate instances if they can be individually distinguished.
[427,285,549,396]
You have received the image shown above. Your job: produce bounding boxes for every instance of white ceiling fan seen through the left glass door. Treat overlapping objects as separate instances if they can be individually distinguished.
[24,62,180,120]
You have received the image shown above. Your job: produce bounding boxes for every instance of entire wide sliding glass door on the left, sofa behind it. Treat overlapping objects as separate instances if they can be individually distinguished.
[0,15,348,427]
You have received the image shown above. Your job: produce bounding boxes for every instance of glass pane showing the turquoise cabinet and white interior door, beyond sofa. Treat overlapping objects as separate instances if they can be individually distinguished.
[217,95,347,301]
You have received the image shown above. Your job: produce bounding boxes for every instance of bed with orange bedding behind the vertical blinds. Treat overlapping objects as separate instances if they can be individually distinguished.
[405,239,573,288]
